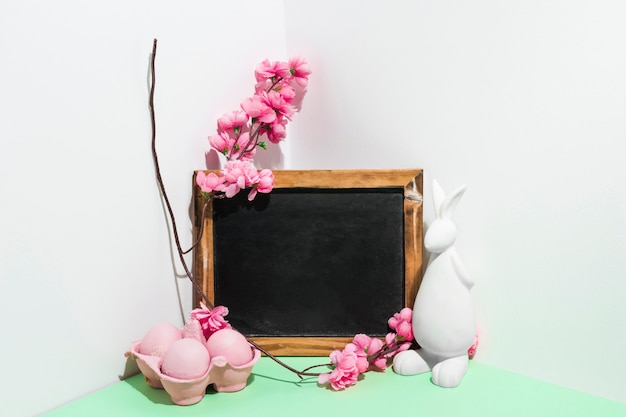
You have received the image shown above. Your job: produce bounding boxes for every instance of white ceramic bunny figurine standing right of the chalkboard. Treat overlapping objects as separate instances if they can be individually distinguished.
[393,181,476,387]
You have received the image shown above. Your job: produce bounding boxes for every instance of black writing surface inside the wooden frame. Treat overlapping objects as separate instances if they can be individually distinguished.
[213,188,404,337]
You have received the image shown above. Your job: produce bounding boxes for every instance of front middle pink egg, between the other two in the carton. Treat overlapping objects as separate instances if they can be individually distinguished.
[161,339,211,380]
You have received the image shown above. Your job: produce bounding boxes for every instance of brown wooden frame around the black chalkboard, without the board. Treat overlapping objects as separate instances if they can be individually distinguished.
[193,169,423,356]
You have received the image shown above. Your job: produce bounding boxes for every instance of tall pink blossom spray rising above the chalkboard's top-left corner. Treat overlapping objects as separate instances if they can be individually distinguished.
[196,56,311,200]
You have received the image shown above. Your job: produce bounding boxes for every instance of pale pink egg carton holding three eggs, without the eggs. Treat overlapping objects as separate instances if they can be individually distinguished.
[126,340,261,405]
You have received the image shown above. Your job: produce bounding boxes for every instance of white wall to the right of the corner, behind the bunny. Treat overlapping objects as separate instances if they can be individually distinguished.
[286,0,626,402]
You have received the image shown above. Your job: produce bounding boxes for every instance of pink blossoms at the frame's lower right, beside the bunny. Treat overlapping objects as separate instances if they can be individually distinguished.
[317,308,413,391]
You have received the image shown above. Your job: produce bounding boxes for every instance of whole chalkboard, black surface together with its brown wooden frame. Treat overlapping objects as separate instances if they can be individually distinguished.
[194,170,422,355]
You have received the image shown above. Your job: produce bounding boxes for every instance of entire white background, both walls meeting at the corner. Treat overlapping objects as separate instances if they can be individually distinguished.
[0,0,626,417]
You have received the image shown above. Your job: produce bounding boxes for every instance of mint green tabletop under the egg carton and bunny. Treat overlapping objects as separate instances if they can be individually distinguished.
[44,357,626,417]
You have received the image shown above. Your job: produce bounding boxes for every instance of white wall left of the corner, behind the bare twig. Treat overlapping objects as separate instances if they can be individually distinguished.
[0,0,285,417]
